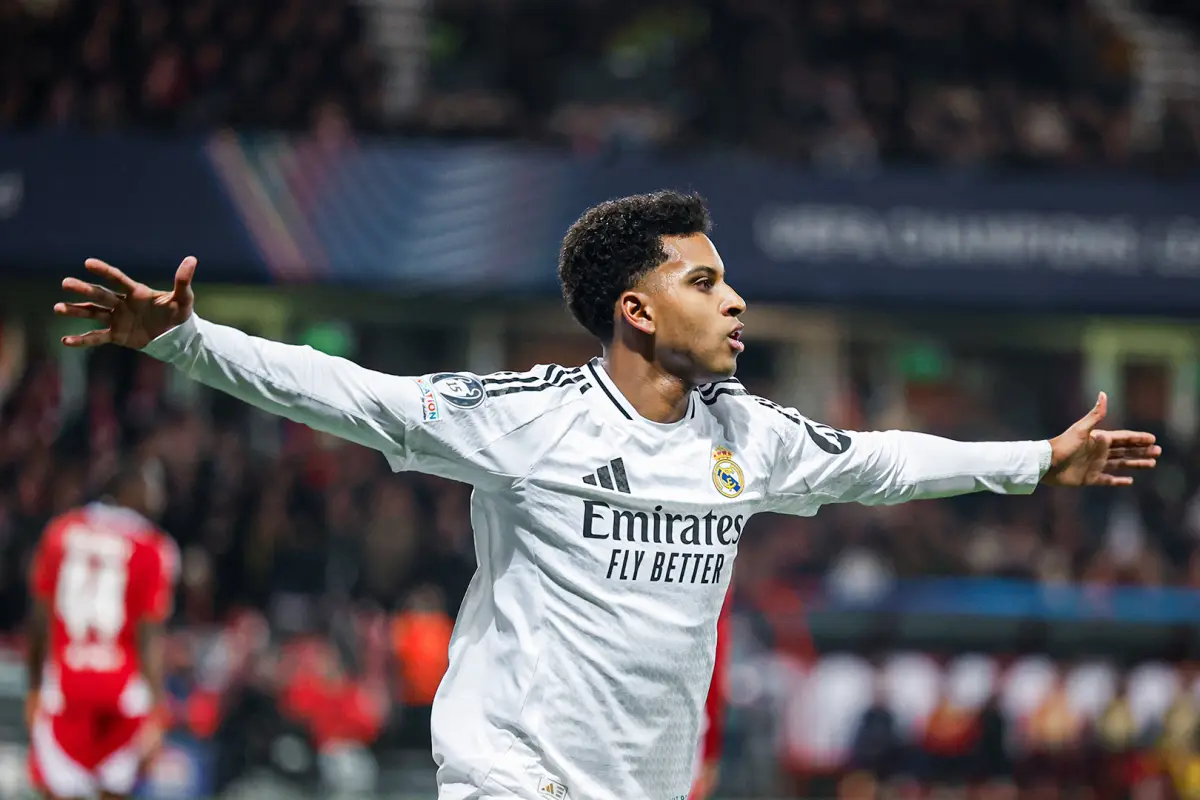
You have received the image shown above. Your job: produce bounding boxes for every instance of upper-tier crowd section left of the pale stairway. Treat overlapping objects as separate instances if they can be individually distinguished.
[0,0,382,133]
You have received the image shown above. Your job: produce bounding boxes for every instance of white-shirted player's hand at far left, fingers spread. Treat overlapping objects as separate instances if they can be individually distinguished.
[54,255,196,350]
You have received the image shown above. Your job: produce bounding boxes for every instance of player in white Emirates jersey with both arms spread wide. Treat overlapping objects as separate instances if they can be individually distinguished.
[55,192,1158,800]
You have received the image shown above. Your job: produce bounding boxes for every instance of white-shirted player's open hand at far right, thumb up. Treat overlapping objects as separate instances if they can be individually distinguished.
[1042,392,1163,486]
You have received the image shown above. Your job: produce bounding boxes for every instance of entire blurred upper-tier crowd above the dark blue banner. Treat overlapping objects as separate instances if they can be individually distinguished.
[0,0,1200,170]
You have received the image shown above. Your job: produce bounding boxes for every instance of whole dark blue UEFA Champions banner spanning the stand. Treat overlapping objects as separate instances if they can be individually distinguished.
[0,134,1200,313]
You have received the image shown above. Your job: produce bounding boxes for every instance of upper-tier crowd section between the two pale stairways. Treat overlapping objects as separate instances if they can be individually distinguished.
[431,0,1147,168]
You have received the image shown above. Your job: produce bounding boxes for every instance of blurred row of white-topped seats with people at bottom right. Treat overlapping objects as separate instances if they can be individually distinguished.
[744,652,1200,800]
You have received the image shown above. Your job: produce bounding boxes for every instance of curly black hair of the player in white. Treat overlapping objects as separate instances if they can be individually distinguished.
[558,191,712,342]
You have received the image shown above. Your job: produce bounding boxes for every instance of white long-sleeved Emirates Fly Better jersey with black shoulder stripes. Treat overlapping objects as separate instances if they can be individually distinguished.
[145,315,1050,800]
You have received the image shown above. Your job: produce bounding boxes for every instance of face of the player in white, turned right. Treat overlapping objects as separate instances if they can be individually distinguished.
[644,234,746,384]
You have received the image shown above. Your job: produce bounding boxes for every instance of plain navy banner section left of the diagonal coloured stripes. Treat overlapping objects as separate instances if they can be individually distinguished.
[0,133,268,282]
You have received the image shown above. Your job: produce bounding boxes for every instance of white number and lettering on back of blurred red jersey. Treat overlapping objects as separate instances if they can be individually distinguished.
[54,527,133,672]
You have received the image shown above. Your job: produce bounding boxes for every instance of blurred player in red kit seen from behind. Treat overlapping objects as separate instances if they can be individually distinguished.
[26,464,179,800]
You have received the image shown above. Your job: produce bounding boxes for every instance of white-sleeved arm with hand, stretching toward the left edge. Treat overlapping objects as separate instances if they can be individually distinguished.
[54,257,540,486]
